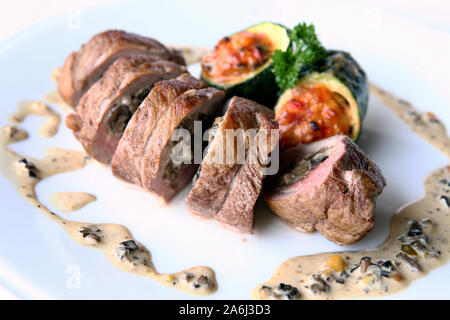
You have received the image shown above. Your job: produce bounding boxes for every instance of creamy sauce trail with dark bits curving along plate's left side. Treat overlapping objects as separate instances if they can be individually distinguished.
[0,102,217,295]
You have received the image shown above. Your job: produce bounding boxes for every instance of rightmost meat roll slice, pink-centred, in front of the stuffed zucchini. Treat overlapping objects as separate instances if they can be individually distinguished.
[264,135,386,245]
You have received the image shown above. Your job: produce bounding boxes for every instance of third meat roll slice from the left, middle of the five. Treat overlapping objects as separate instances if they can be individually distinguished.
[112,76,225,202]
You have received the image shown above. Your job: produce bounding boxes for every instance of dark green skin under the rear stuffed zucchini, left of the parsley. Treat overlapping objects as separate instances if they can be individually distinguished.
[206,65,278,109]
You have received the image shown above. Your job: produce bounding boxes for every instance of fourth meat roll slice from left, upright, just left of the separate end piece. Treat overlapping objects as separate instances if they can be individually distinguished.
[186,97,278,233]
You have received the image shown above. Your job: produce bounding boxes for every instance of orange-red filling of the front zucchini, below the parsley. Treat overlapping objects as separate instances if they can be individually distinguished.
[276,84,353,148]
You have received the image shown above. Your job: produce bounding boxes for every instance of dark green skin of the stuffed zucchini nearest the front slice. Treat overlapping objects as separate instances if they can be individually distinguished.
[319,50,369,124]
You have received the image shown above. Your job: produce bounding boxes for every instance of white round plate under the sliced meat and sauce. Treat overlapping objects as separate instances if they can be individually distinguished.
[0,0,450,299]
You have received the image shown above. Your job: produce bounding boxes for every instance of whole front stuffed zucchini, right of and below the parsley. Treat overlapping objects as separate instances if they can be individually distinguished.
[275,50,369,148]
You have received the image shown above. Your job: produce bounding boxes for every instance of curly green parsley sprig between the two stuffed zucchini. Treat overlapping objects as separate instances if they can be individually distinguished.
[272,23,327,91]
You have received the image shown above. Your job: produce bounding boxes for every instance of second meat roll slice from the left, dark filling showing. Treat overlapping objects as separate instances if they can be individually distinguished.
[66,55,186,164]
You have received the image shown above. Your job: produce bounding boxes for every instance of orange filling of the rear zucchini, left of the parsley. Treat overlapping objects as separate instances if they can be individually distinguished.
[202,31,275,85]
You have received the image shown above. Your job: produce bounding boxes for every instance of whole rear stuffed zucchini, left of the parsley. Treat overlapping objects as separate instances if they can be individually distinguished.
[201,22,290,106]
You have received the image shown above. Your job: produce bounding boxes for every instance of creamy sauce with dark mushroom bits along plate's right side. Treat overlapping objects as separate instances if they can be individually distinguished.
[252,85,450,299]
